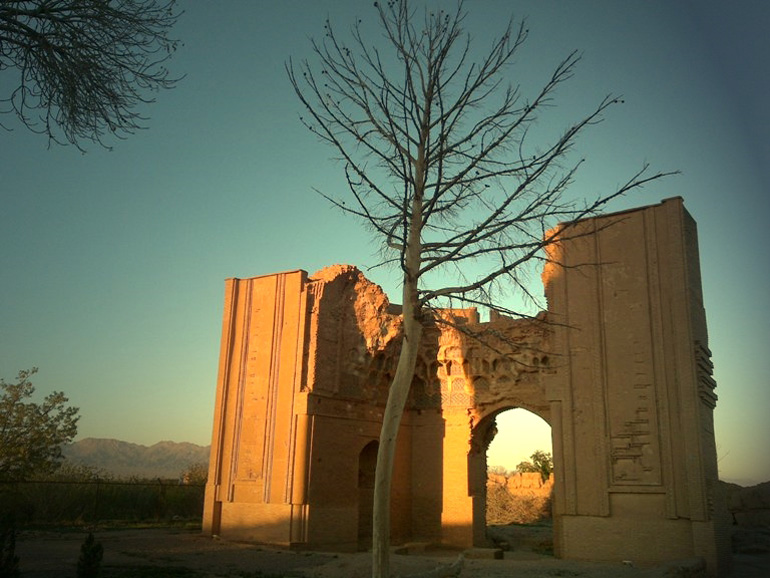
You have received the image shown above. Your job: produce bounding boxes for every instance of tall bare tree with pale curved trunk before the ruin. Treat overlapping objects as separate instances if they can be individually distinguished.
[287,0,663,577]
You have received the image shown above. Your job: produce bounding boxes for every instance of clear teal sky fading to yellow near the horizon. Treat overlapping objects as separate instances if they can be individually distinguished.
[0,0,770,482]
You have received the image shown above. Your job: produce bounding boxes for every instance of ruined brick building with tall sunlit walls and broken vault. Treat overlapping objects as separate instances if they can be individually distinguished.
[204,198,729,574]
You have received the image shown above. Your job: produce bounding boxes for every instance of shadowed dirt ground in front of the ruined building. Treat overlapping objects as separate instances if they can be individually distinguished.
[16,527,770,578]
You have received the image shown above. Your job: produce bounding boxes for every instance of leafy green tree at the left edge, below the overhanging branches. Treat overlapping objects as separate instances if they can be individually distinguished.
[0,368,79,480]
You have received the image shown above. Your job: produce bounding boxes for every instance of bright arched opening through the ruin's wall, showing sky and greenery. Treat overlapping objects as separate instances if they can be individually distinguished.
[480,408,554,555]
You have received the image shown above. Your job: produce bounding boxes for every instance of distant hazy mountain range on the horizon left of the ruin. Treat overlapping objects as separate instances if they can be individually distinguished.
[62,438,210,479]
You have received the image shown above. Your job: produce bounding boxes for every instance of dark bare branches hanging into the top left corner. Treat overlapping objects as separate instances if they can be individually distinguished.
[0,0,178,148]
